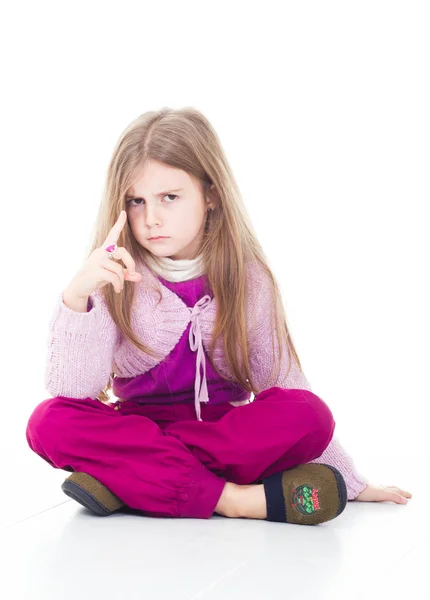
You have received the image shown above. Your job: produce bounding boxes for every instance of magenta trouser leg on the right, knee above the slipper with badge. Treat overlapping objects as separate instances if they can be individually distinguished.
[164,387,336,484]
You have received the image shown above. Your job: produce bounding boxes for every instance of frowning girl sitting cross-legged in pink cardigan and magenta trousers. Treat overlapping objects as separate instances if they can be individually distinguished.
[26,108,411,525]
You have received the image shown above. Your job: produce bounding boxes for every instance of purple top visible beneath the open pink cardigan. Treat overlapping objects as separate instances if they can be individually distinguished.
[112,275,251,414]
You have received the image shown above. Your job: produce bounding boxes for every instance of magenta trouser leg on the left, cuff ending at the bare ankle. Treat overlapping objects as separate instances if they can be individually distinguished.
[26,396,226,518]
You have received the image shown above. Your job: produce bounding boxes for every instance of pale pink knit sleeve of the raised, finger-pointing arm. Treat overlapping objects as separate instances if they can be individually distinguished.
[45,290,119,399]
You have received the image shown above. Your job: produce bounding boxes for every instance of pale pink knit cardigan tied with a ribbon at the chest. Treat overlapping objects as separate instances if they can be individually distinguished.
[45,262,368,500]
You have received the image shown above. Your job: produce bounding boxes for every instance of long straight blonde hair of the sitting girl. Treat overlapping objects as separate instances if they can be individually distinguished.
[89,107,302,402]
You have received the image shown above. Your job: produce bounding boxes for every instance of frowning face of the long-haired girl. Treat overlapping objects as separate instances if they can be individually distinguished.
[125,161,209,260]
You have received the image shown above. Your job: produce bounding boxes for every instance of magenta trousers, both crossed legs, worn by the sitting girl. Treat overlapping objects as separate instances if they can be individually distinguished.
[26,387,335,519]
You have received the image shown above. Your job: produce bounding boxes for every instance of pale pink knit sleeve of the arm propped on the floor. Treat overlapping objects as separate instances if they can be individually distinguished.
[248,264,368,500]
